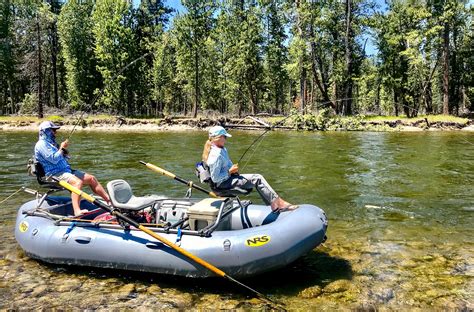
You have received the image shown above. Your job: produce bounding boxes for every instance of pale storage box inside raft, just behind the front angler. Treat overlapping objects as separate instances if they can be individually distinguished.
[188,198,224,231]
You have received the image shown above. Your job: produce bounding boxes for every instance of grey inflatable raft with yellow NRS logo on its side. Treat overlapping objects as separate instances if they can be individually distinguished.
[15,196,327,277]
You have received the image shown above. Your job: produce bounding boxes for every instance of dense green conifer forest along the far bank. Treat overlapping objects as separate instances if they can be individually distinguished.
[0,0,474,118]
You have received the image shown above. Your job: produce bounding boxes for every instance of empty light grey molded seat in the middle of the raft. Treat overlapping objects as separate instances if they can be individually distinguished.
[107,180,165,211]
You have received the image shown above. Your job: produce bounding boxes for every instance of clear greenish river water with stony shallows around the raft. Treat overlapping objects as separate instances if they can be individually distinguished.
[0,131,474,310]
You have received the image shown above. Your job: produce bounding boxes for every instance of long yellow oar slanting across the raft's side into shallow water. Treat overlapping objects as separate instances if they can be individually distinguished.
[53,178,281,308]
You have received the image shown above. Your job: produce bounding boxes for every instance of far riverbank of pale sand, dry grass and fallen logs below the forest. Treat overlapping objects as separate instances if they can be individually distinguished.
[0,115,474,132]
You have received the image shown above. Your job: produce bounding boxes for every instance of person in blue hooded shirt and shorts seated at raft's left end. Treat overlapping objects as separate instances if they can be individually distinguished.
[35,121,110,216]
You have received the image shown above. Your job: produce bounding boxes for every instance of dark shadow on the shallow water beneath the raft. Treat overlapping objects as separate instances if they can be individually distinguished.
[31,250,353,299]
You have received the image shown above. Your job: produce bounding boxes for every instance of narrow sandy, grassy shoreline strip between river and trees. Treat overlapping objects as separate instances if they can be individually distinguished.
[0,116,474,132]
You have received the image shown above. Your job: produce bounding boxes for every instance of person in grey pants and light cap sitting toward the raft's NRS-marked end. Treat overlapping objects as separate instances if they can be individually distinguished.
[202,126,298,211]
